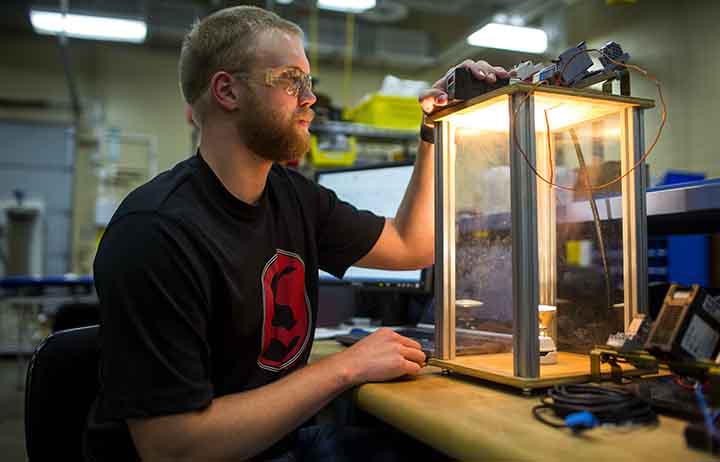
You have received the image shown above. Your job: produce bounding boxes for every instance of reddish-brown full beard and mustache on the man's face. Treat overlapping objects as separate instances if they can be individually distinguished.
[236,90,314,162]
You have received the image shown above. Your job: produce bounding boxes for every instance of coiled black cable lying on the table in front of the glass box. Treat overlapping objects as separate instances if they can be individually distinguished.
[532,385,657,428]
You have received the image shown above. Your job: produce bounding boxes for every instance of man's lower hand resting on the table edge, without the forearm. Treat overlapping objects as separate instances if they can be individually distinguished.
[337,328,426,385]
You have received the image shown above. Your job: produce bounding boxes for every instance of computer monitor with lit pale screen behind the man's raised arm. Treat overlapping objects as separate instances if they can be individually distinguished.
[316,162,431,292]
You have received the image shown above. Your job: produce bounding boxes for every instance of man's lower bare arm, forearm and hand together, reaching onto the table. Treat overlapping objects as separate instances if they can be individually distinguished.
[128,329,425,461]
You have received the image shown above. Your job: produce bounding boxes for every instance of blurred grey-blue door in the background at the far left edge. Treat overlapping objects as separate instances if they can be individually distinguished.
[0,120,75,276]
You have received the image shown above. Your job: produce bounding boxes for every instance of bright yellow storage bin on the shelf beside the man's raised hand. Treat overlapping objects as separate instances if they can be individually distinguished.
[344,93,422,130]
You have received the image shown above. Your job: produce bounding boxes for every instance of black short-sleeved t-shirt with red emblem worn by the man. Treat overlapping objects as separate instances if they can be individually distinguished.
[86,155,384,461]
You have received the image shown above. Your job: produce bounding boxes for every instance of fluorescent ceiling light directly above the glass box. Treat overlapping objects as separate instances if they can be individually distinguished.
[467,23,547,53]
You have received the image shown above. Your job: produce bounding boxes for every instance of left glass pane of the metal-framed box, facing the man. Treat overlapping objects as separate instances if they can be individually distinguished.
[451,97,513,359]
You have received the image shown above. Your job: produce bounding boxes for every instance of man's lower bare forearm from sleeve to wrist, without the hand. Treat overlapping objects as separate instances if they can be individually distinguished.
[130,356,355,461]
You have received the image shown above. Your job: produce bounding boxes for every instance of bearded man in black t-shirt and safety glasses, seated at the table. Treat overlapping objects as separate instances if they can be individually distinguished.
[86,7,506,461]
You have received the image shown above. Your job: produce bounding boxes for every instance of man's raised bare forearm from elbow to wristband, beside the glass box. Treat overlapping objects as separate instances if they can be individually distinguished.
[395,137,435,263]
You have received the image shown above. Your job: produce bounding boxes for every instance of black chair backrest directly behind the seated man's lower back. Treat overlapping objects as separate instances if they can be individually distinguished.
[25,325,99,462]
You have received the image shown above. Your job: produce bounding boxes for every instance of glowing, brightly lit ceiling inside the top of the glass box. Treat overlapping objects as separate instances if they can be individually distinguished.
[448,92,626,132]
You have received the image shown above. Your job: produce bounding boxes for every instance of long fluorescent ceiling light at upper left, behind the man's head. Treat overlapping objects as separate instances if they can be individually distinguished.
[30,10,147,43]
